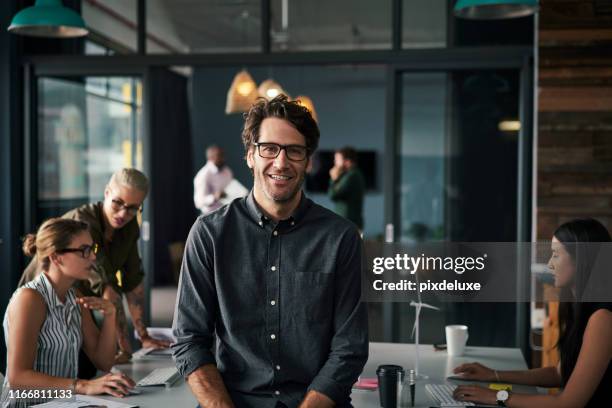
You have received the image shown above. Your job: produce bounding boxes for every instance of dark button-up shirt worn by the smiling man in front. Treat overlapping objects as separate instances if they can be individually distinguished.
[172,192,368,407]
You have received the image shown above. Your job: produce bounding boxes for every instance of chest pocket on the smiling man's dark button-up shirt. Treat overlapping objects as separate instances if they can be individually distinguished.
[283,271,334,322]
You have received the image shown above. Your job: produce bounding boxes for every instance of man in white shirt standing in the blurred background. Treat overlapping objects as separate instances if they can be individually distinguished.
[193,145,234,214]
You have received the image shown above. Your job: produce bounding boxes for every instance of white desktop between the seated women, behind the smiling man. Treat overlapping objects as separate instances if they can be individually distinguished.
[103,343,536,408]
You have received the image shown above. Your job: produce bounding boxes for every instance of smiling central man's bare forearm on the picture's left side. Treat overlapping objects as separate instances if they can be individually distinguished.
[187,364,234,408]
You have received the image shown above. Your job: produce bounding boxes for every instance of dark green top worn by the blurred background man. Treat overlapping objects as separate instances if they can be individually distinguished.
[327,167,365,230]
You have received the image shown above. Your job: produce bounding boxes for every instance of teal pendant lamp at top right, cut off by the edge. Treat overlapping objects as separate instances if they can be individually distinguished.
[455,0,538,20]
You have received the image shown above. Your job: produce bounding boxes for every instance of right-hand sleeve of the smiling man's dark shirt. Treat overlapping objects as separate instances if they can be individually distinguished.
[308,230,368,404]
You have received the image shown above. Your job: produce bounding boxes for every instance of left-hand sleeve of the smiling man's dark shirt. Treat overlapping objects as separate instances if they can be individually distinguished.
[171,219,219,376]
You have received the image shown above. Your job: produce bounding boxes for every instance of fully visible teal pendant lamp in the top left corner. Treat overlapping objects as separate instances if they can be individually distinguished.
[8,0,89,38]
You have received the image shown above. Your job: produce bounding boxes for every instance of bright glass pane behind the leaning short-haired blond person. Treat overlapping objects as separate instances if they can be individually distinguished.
[36,77,143,222]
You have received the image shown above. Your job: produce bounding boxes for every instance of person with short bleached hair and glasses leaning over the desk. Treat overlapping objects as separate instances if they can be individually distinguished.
[19,168,170,364]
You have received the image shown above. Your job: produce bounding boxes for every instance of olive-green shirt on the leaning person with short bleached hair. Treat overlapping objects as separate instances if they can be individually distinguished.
[19,202,144,296]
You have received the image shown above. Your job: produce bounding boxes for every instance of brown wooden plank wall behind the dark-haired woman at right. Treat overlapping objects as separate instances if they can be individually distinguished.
[534,0,612,366]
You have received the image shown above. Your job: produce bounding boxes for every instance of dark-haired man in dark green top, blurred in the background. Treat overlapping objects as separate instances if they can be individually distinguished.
[327,147,365,231]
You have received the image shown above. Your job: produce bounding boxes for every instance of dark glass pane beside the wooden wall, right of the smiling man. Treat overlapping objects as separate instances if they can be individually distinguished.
[395,70,520,346]
